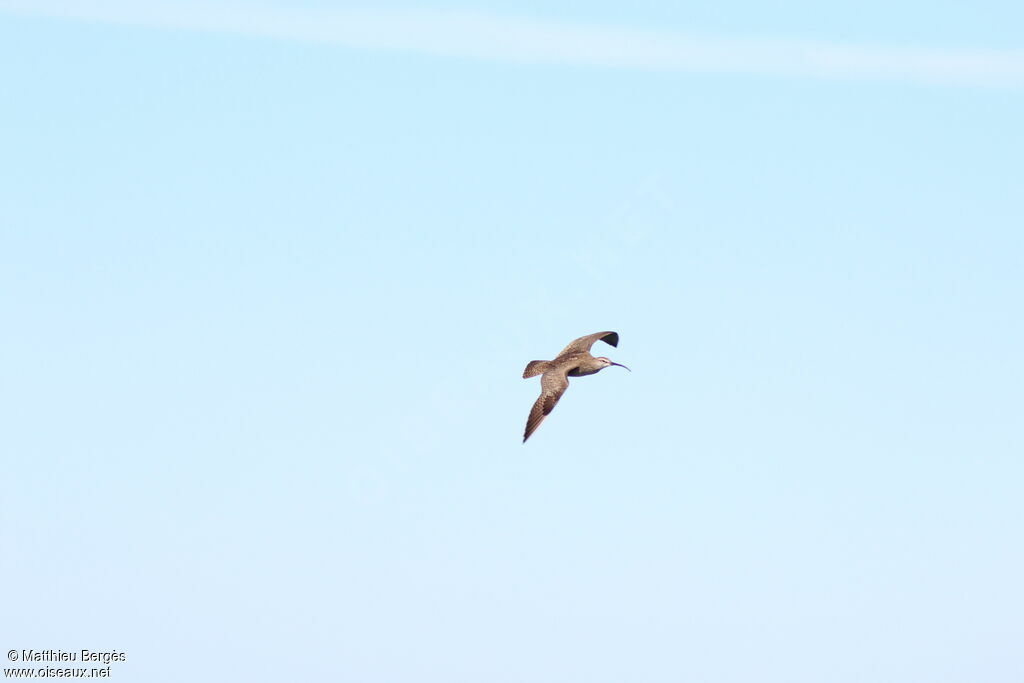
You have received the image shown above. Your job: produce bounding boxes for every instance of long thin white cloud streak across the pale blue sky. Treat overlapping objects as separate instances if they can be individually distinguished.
[0,0,1024,87]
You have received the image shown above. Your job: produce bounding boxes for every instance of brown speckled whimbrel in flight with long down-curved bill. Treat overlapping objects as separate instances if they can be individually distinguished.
[522,332,629,443]
